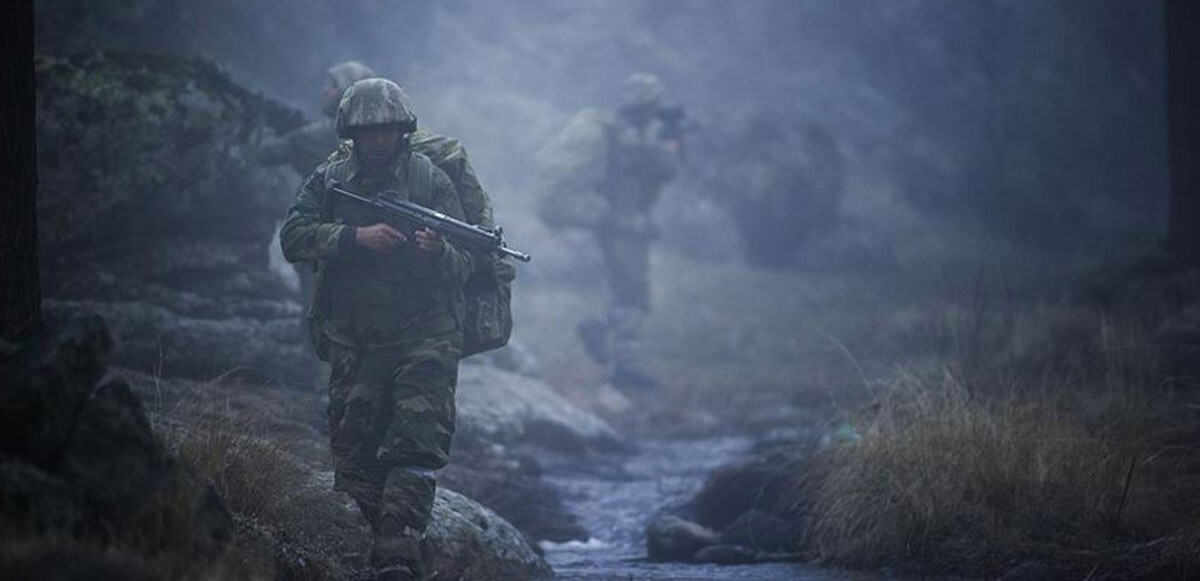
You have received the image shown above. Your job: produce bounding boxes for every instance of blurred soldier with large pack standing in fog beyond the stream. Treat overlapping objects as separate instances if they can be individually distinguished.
[539,73,683,389]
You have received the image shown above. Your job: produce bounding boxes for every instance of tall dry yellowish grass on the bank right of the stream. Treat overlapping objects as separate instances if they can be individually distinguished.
[792,292,1200,579]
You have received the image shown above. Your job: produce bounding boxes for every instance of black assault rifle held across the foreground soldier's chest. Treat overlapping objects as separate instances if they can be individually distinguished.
[329,181,532,262]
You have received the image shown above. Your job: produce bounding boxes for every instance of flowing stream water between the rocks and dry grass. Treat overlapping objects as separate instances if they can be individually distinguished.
[542,437,883,581]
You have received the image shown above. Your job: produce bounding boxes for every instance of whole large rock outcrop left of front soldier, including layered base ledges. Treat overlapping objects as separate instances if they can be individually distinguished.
[36,52,317,382]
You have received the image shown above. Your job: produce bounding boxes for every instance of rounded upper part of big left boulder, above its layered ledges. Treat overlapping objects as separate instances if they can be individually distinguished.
[35,52,302,249]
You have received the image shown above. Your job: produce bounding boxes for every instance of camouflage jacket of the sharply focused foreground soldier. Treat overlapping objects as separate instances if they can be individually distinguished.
[280,143,475,345]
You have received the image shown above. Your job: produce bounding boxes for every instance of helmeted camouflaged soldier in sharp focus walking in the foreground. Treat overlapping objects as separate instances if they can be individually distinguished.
[281,78,491,579]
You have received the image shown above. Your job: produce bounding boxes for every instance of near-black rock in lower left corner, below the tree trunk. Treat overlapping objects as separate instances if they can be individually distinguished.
[0,313,233,571]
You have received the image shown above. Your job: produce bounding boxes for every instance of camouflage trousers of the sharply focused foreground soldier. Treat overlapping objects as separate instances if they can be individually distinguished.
[329,339,458,568]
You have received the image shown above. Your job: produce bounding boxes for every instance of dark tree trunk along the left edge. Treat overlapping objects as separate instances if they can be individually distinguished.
[0,0,42,340]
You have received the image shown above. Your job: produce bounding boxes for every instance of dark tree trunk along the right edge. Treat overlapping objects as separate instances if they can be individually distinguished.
[1164,0,1200,264]
